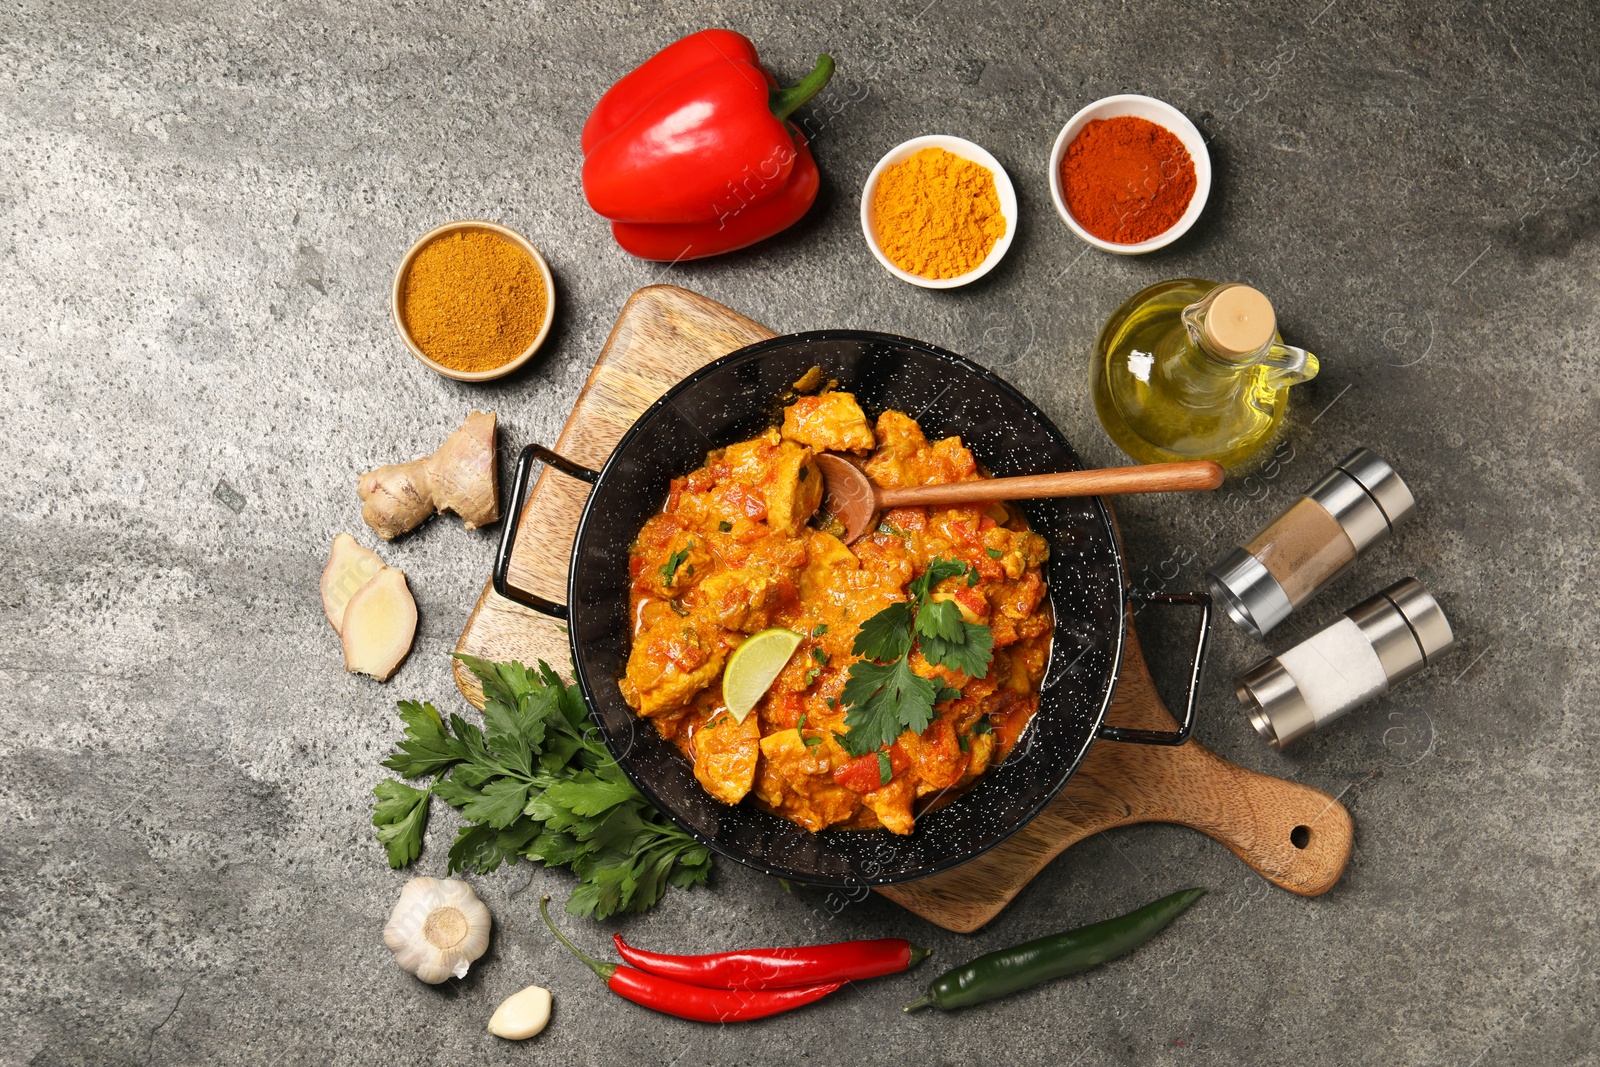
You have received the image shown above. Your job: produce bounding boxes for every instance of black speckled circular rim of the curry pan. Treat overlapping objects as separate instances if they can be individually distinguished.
[566,330,1128,888]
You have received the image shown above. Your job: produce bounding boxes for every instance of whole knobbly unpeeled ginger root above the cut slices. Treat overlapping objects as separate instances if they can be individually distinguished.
[355,411,499,541]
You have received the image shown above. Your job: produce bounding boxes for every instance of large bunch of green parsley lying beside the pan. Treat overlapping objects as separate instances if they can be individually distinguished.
[373,656,710,918]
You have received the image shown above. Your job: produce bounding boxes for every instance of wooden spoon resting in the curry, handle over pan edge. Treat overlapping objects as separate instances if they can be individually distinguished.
[816,453,1222,544]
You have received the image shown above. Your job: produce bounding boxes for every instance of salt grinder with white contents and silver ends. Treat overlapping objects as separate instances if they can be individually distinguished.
[1234,577,1456,749]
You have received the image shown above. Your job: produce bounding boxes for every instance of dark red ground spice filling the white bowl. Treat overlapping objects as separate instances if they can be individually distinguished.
[1061,115,1195,245]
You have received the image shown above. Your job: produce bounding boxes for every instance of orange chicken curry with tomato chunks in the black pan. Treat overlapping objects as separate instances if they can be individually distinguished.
[622,390,1051,833]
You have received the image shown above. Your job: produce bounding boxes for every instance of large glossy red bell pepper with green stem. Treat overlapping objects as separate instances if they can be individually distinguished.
[582,30,834,261]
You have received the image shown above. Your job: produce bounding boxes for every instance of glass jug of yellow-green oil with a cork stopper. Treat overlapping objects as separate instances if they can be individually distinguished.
[1090,278,1318,467]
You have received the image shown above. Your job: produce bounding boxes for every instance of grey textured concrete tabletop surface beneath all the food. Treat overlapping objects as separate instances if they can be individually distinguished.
[0,0,1600,1067]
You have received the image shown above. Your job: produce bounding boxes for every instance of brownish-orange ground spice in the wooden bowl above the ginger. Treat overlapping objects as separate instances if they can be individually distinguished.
[400,229,549,371]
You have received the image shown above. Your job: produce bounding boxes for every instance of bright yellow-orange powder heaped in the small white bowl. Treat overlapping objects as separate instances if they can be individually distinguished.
[872,149,1006,278]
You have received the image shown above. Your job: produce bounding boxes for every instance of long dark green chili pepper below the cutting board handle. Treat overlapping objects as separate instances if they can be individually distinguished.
[906,888,1205,1011]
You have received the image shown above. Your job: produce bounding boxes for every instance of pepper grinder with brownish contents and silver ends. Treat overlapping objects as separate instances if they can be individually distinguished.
[1206,448,1416,638]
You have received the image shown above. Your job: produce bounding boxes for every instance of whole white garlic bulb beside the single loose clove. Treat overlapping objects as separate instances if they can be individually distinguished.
[384,878,490,985]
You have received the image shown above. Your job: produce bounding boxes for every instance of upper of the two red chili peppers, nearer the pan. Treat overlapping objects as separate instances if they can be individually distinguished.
[611,934,928,989]
